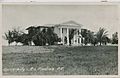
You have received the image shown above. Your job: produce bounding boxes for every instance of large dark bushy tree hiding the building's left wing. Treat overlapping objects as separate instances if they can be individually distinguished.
[30,27,60,46]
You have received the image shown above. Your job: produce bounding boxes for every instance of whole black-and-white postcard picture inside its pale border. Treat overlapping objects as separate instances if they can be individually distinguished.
[2,4,119,76]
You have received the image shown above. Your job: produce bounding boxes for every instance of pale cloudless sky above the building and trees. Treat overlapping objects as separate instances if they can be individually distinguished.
[2,4,119,45]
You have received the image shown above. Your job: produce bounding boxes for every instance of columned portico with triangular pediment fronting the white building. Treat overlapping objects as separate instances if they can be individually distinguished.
[53,21,83,45]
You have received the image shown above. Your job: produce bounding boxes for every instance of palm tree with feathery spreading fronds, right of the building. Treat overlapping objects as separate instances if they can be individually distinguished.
[96,27,108,46]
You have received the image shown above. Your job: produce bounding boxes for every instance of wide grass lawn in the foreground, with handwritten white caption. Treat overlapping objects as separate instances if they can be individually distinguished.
[2,46,118,75]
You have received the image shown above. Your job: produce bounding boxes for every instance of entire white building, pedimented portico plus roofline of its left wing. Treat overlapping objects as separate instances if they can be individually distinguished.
[27,21,83,45]
